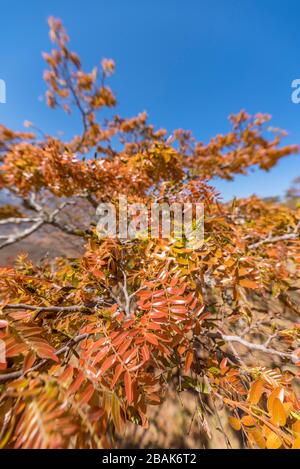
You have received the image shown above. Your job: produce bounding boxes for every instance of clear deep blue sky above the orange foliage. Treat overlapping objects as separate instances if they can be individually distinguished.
[0,0,300,199]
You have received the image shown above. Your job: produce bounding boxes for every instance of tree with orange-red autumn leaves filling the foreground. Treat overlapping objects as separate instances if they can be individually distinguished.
[0,18,300,448]
